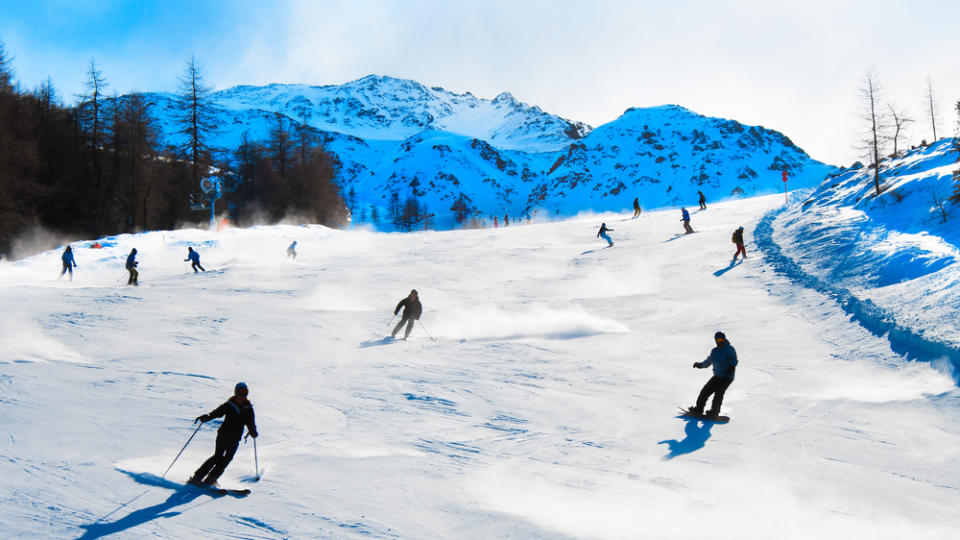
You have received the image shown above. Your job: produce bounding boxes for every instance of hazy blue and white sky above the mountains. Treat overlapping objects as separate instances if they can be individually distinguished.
[0,0,960,164]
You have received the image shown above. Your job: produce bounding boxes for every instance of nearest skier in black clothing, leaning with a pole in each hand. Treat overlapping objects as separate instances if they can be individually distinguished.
[187,382,259,486]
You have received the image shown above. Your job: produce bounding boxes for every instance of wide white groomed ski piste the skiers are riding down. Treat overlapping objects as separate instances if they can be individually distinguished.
[0,196,960,539]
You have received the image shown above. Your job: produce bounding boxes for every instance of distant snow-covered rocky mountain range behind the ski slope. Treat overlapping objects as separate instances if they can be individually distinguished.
[141,76,833,229]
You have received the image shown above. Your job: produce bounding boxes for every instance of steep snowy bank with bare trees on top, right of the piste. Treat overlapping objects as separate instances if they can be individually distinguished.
[773,139,960,354]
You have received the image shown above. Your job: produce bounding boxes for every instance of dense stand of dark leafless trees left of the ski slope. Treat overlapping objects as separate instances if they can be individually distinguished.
[0,42,347,257]
